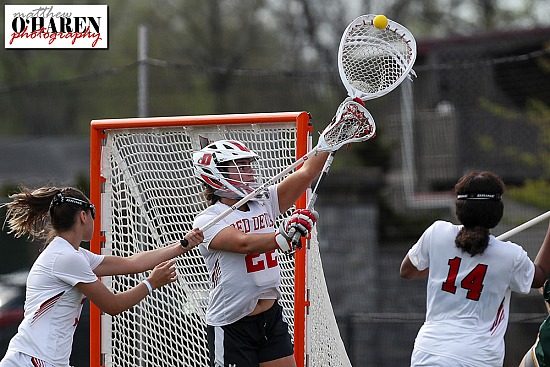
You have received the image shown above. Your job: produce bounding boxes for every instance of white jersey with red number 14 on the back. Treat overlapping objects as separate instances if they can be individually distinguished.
[408,221,535,367]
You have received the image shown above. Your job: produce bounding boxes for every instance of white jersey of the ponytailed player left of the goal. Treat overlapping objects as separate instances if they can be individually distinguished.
[8,237,104,367]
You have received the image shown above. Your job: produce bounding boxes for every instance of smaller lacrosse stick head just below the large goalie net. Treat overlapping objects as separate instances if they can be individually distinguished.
[317,98,376,152]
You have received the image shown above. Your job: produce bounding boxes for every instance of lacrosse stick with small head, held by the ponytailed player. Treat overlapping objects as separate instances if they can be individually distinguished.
[181,101,376,246]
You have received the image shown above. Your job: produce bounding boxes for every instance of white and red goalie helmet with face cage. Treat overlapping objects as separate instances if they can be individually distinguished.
[193,140,262,199]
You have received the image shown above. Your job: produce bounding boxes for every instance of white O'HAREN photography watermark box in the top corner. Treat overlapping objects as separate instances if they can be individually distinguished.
[4,5,109,49]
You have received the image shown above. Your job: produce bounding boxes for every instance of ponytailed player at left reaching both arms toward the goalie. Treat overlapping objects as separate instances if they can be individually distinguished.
[0,187,204,367]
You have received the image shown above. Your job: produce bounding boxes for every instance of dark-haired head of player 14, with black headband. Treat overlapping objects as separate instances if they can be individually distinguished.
[455,171,504,256]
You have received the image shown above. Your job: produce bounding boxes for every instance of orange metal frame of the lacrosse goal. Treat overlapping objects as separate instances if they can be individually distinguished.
[90,111,312,367]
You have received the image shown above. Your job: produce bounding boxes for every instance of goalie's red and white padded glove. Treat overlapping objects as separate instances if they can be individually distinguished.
[275,209,319,252]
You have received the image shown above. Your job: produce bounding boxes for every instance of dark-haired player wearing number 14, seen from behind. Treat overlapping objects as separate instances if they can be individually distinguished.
[400,172,550,367]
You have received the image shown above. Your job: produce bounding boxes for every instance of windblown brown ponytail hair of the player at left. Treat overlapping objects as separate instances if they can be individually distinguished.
[4,187,89,244]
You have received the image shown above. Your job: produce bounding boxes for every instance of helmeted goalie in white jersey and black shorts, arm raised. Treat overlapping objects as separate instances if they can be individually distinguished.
[193,140,328,367]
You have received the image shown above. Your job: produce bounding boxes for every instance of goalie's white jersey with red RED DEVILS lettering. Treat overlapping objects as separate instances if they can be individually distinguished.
[193,186,281,326]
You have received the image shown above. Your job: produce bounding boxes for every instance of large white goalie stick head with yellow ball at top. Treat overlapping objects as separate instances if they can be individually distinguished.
[338,14,416,100]
